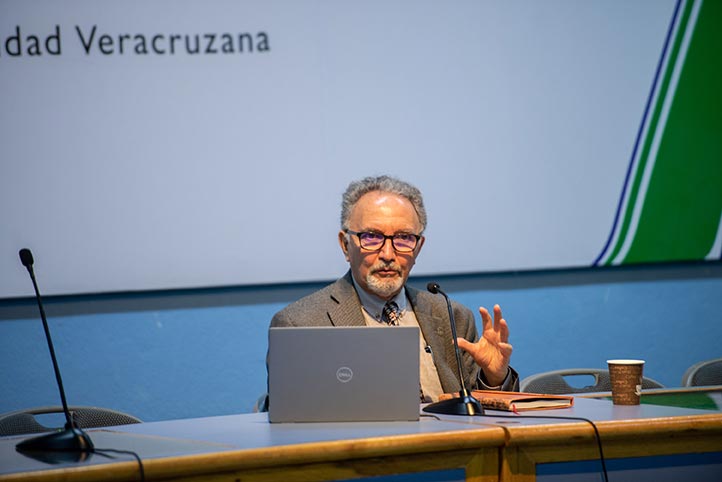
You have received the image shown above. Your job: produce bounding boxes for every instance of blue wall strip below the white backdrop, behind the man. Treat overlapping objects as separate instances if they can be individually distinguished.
[0,265,722,421]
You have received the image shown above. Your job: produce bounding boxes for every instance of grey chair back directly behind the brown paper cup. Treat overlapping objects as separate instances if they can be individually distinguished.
[519,368,664,394]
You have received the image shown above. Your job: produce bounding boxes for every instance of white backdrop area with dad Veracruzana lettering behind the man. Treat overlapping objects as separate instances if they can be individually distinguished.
[0,0,674,297]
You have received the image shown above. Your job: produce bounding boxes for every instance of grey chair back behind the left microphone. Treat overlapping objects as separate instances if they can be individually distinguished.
[0,406,142,436]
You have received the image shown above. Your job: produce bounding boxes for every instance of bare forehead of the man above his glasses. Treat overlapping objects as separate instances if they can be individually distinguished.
[349,191,420,232]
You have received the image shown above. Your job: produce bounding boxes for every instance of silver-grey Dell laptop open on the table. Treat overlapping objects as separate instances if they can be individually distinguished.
[268,326,420,422]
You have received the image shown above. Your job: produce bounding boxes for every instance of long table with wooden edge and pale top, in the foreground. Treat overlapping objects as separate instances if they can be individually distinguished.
[0,397,722,482]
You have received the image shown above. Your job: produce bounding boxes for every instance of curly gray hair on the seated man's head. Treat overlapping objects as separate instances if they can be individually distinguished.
[341,176,426,232]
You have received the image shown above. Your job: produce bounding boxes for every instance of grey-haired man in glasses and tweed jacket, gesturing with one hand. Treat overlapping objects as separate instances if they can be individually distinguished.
[271,176,519,402]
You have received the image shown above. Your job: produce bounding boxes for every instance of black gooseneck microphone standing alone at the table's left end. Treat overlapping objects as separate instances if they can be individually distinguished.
[15,248,93,461]
